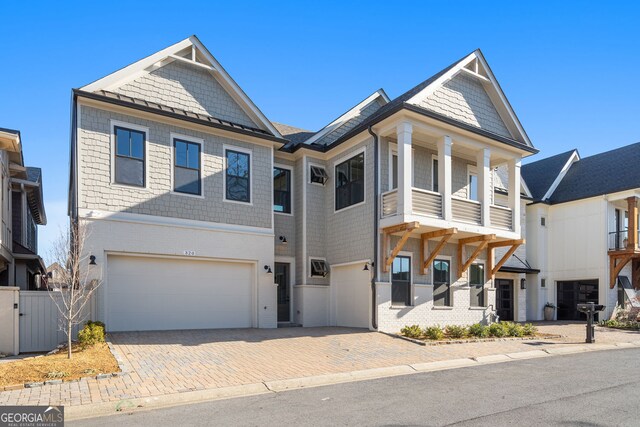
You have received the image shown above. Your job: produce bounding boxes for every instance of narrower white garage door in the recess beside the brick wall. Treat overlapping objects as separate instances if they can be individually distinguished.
[331,264,371,328]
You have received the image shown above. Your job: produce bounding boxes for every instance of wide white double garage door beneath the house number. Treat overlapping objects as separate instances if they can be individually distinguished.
[104,255,254,331]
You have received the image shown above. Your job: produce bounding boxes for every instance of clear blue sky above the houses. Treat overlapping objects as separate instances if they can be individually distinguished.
[0,1,640,259]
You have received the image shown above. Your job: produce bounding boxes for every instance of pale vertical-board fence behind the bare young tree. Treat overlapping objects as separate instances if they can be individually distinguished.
[19,291,96,353]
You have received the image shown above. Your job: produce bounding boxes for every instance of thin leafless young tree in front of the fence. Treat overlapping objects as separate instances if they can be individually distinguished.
[48,222,102,359]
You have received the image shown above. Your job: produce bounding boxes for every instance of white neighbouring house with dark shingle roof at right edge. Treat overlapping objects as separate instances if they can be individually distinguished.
[522,144,640,320]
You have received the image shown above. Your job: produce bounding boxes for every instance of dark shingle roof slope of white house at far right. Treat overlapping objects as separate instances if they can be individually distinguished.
[549,143,640,204]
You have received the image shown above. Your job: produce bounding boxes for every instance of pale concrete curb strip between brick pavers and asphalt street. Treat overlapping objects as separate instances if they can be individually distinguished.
[65,342,640,421]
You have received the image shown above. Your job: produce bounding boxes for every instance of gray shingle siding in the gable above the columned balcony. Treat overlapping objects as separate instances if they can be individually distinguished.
[416,74,513,138]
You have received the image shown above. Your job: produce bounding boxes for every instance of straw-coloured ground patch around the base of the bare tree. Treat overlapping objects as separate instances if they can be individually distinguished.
[0,343,120,387]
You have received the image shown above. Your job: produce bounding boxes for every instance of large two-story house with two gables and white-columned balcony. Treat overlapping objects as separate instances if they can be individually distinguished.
[69,36,537,331]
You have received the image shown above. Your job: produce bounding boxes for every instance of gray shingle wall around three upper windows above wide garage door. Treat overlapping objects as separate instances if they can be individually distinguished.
[78,106,272,228]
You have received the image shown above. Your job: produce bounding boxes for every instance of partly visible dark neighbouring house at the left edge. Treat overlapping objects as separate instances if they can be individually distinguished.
[0,129,47,291]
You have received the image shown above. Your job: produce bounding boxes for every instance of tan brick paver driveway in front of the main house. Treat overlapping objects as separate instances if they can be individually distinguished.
[0,324,640,405]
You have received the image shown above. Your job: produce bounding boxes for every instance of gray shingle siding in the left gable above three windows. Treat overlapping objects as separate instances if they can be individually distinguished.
[113,61,256,127]
